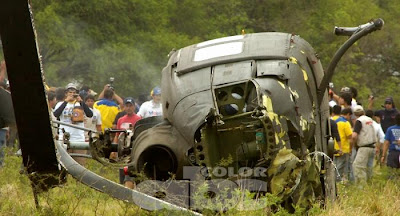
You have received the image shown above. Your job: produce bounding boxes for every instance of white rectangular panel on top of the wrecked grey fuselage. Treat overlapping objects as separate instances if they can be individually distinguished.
[194,42,243,61]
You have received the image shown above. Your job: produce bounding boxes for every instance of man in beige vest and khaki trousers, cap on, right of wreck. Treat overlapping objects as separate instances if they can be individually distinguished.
[352,105,378,182]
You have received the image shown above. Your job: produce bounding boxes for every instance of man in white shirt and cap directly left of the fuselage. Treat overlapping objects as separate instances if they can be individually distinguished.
[138,87,162,118]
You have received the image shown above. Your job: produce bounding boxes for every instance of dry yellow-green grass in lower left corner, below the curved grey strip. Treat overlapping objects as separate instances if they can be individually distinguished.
[0,148,148,216]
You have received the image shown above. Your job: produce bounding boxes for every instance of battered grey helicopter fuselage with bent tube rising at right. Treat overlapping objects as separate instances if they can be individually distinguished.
[118,19,383,207]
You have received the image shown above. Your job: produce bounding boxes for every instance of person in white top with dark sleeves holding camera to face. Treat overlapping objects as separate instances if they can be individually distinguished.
[53,83,93,164]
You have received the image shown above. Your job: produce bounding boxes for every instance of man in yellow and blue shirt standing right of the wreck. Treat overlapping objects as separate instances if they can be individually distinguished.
[332,105,353,180]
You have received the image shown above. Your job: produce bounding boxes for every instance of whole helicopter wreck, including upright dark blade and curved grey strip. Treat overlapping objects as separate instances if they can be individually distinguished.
[0,1,383,214]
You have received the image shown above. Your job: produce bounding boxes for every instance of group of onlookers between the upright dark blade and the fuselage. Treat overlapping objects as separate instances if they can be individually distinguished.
[47,83,162,142]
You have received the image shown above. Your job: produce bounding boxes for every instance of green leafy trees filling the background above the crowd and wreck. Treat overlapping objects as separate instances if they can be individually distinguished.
[21,0,400,105]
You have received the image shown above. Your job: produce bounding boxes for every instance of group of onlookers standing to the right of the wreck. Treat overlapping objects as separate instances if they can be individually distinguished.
[329,87,400,182]
